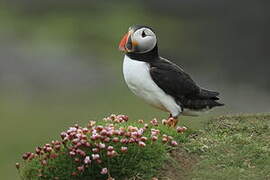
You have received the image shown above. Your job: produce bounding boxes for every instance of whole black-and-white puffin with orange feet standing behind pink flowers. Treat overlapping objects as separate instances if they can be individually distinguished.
[119,25,224,127]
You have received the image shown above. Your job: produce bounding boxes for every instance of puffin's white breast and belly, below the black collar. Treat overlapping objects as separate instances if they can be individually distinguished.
[123,56,181,116]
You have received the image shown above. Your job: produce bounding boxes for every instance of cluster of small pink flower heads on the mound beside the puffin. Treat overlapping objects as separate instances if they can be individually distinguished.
[16,114,186,180]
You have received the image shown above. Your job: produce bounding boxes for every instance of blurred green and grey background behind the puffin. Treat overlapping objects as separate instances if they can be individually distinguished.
[0,0,270,180]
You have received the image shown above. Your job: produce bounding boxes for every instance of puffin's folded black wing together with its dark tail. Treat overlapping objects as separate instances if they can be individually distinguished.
[150,58,223,109]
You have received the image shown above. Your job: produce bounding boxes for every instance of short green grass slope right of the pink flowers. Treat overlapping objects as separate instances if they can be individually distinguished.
[175,114,270,180]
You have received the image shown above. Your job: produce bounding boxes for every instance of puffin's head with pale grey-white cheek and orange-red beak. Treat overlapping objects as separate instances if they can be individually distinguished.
[119,25,157,53]
